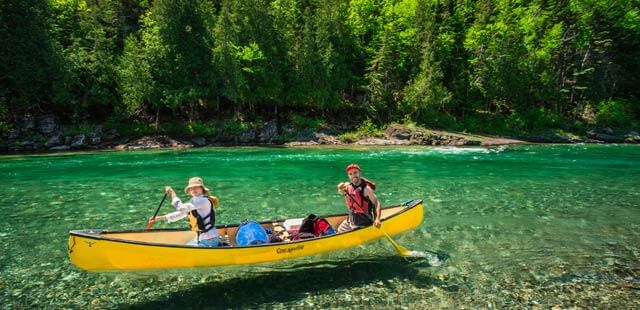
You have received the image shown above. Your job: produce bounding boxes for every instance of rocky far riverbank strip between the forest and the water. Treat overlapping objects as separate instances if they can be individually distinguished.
[0,117,640,154]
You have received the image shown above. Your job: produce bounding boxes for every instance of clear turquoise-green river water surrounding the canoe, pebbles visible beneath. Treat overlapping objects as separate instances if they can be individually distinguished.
[0,145,640,309]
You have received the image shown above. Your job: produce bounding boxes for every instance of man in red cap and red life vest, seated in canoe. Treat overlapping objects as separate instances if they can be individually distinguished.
[338,164,382,233]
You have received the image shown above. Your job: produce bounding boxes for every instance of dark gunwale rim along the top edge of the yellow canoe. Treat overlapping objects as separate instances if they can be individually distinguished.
[69,199,423,250]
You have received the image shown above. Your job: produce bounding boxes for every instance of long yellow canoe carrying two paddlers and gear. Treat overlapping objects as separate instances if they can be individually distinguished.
[68,200,424,270]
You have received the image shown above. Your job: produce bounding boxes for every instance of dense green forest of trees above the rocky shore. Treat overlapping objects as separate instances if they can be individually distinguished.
[0,0,640,137]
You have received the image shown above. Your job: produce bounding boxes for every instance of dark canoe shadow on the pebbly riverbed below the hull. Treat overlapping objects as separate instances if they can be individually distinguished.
[120,256,452,309]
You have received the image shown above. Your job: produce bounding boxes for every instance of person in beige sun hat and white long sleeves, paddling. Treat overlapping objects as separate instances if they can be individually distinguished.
[149,177,220,247]
